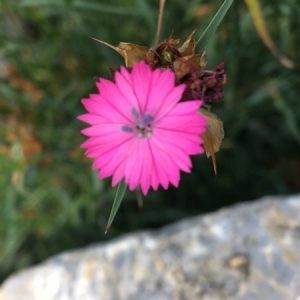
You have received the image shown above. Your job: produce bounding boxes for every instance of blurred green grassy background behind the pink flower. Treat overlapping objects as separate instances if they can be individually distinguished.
[0,0,300,280]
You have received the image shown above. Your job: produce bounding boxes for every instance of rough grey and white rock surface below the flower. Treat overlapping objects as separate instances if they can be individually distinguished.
[0,195,300,300]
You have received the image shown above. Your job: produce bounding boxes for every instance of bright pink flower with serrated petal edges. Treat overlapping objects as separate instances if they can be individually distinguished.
[78,61,206,195]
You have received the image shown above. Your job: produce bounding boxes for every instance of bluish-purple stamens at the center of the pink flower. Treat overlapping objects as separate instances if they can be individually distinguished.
[121,107,154,138]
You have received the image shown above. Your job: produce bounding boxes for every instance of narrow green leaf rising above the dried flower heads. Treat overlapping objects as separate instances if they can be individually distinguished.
[197,0,233,49]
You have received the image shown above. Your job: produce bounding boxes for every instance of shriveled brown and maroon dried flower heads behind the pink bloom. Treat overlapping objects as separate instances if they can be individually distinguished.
[91,29,226,102]
